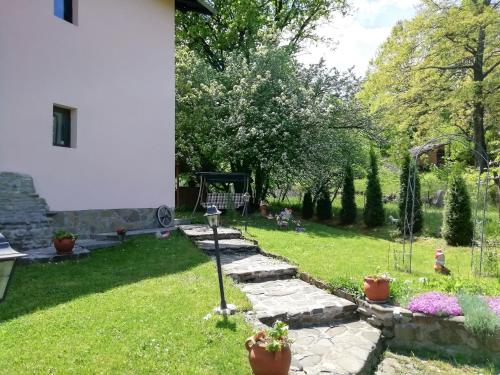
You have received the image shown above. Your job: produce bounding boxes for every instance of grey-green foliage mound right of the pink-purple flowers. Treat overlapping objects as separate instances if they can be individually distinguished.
[458,293,500,337]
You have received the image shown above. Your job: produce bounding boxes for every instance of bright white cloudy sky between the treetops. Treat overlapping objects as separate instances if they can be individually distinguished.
[299,0,418,76]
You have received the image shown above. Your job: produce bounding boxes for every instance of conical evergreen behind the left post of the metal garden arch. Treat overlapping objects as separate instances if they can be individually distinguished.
[399,153,423,233]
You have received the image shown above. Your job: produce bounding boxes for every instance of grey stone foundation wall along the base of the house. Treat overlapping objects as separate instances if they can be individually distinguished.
[52,208,159,238]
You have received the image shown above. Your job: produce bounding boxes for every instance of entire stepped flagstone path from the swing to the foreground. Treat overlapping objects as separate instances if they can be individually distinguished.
[179,225,382,375]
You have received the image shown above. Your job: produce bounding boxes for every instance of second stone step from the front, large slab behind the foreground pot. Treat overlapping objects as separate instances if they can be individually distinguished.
[240,279,357,328]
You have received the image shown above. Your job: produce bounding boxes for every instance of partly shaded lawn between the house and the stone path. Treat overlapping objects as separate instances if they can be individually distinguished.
[0,233,251,374]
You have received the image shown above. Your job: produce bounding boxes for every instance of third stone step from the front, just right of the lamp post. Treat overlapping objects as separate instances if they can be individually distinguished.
[221,252,297,282]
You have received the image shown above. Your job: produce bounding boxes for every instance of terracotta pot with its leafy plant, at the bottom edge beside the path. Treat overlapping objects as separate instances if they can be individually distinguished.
[245,320,292,375]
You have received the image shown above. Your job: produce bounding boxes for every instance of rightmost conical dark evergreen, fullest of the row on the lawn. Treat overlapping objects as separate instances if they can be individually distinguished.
[442,173,474,246]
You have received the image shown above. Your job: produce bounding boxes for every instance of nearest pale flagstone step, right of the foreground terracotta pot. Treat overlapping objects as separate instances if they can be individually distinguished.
[289,321,383,375]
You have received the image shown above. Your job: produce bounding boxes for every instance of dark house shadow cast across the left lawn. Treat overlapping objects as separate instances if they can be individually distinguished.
[0,232,209,322]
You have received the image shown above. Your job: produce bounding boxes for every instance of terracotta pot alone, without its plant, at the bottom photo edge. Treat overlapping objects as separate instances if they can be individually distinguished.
[245,336,292,375]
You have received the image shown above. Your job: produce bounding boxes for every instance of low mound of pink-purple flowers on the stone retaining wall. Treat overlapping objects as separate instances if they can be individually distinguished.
[408,292,462,316]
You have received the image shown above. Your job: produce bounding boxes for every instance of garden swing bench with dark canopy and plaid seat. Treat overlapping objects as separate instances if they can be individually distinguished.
[193,172,251,215]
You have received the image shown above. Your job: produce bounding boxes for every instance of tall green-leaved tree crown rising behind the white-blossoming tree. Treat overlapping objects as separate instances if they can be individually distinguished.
[176,0,347,70]
